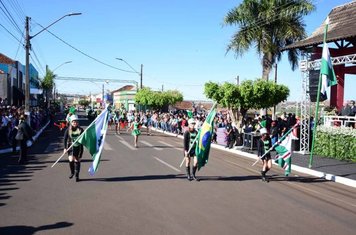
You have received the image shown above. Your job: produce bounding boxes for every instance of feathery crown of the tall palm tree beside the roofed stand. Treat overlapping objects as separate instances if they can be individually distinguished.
[224,0,315,79]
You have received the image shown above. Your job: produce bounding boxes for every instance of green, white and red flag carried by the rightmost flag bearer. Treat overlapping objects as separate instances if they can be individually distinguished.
[275,124,298,176]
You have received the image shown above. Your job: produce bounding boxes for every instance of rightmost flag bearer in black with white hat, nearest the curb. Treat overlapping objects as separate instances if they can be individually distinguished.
[257,128,272,182]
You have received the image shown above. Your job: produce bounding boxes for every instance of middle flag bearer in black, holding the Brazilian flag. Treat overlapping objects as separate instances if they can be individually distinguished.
[183,118,199,181]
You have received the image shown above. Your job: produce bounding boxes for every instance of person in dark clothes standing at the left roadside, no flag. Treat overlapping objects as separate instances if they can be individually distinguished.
[15,114,35,164]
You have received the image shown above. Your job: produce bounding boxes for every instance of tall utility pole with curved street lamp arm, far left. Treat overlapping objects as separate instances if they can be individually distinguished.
[25,13,82,112]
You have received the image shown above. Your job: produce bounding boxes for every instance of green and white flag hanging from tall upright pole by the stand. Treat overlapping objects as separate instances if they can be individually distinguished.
[320,17,337,101]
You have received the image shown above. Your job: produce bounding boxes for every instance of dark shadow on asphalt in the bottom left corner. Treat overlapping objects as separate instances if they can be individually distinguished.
[0,222,73,235]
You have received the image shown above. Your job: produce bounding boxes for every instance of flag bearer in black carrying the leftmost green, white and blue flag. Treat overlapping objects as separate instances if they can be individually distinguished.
[64,115,84,182]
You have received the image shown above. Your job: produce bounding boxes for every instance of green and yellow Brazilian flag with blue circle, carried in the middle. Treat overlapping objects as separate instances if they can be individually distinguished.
[195,108,216,169]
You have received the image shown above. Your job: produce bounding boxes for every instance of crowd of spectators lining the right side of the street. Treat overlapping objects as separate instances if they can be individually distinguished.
[111,107,297,148]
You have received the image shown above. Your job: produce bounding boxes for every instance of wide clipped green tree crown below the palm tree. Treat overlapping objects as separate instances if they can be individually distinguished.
[204,79,289,120]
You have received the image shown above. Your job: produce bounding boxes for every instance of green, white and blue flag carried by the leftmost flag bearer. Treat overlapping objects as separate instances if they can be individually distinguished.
[78,109,108,175]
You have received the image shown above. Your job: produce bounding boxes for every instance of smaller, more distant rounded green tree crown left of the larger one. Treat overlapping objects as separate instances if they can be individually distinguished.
[135,88,183,109]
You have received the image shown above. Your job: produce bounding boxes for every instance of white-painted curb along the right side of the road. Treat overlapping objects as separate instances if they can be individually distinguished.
[151,128,356,188]
